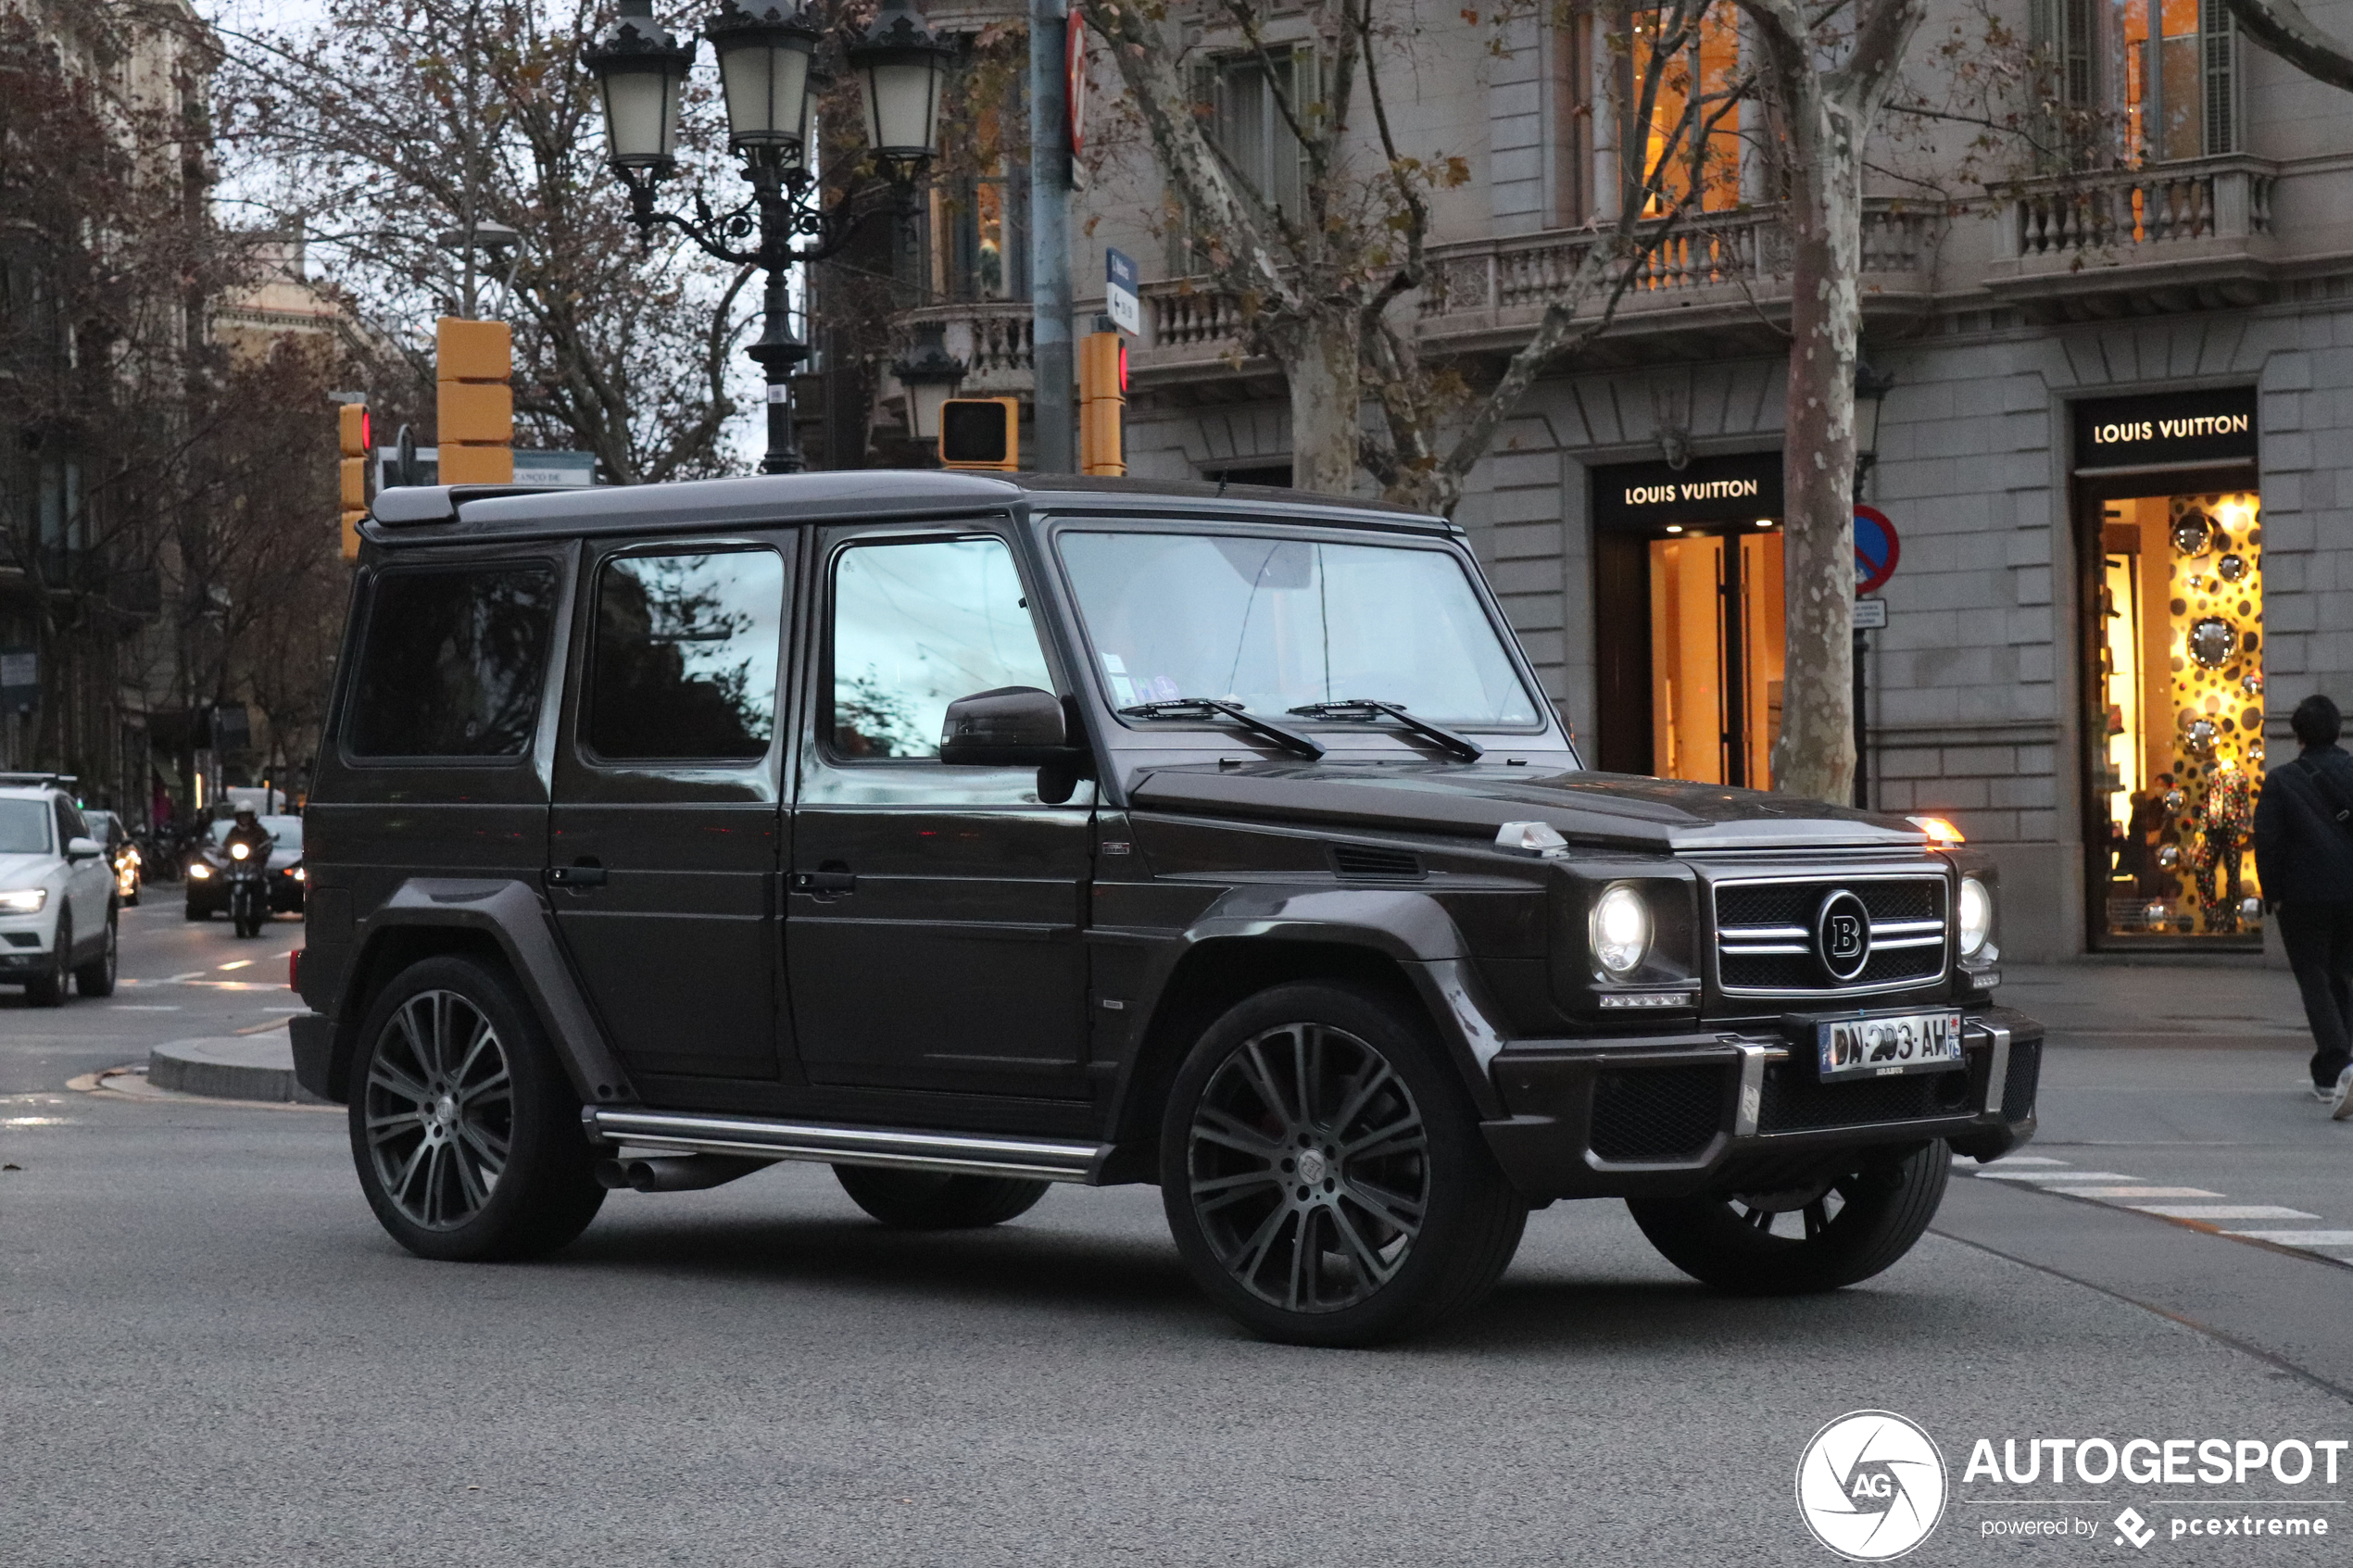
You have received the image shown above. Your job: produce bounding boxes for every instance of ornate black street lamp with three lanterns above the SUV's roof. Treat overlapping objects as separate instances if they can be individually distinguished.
[581,0,955,472]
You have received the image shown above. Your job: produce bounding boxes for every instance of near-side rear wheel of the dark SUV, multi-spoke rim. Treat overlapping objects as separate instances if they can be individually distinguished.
[350,957,605,1262]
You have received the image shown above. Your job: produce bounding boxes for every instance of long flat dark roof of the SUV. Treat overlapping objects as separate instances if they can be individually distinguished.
[365,468,1461,546]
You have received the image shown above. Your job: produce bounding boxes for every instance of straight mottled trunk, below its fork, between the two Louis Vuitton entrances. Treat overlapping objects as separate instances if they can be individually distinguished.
[1772,89,1864,807]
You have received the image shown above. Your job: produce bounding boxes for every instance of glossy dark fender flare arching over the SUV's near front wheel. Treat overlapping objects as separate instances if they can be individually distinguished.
[1108,884,1506,1151]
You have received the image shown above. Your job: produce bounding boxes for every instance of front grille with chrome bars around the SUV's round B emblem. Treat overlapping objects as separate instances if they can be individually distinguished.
[1713,874,1946,997]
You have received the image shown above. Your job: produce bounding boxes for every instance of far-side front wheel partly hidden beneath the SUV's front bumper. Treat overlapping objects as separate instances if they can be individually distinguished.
[1626,1138,1953,1296]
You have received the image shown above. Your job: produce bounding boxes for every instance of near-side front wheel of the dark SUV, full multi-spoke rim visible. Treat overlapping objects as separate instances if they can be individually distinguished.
[1160,983,1527,1345]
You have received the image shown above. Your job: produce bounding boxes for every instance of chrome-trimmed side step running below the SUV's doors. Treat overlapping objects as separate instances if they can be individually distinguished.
[581,1105,1111,1185]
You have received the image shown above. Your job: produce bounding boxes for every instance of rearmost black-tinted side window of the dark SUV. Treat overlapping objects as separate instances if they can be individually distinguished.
[344,562,555,761]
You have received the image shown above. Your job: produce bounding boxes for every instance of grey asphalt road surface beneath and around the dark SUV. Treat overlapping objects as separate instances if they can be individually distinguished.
[0,921,2353,1568]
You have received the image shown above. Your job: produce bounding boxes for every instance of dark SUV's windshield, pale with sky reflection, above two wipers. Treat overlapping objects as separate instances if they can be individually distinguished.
[1062,532,1537,729]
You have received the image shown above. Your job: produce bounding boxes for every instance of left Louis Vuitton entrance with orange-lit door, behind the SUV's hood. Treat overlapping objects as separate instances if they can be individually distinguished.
[1593,454,1786,790]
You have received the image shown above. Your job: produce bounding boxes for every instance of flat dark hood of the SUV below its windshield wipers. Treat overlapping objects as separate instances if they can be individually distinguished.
[1129,761,1927,851]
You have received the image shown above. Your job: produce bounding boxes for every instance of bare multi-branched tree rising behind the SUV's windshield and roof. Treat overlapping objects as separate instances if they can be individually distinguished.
[1085,0,1743,512]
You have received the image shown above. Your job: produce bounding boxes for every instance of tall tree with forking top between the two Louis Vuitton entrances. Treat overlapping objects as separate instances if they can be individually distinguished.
[1737,0,1927,802]
